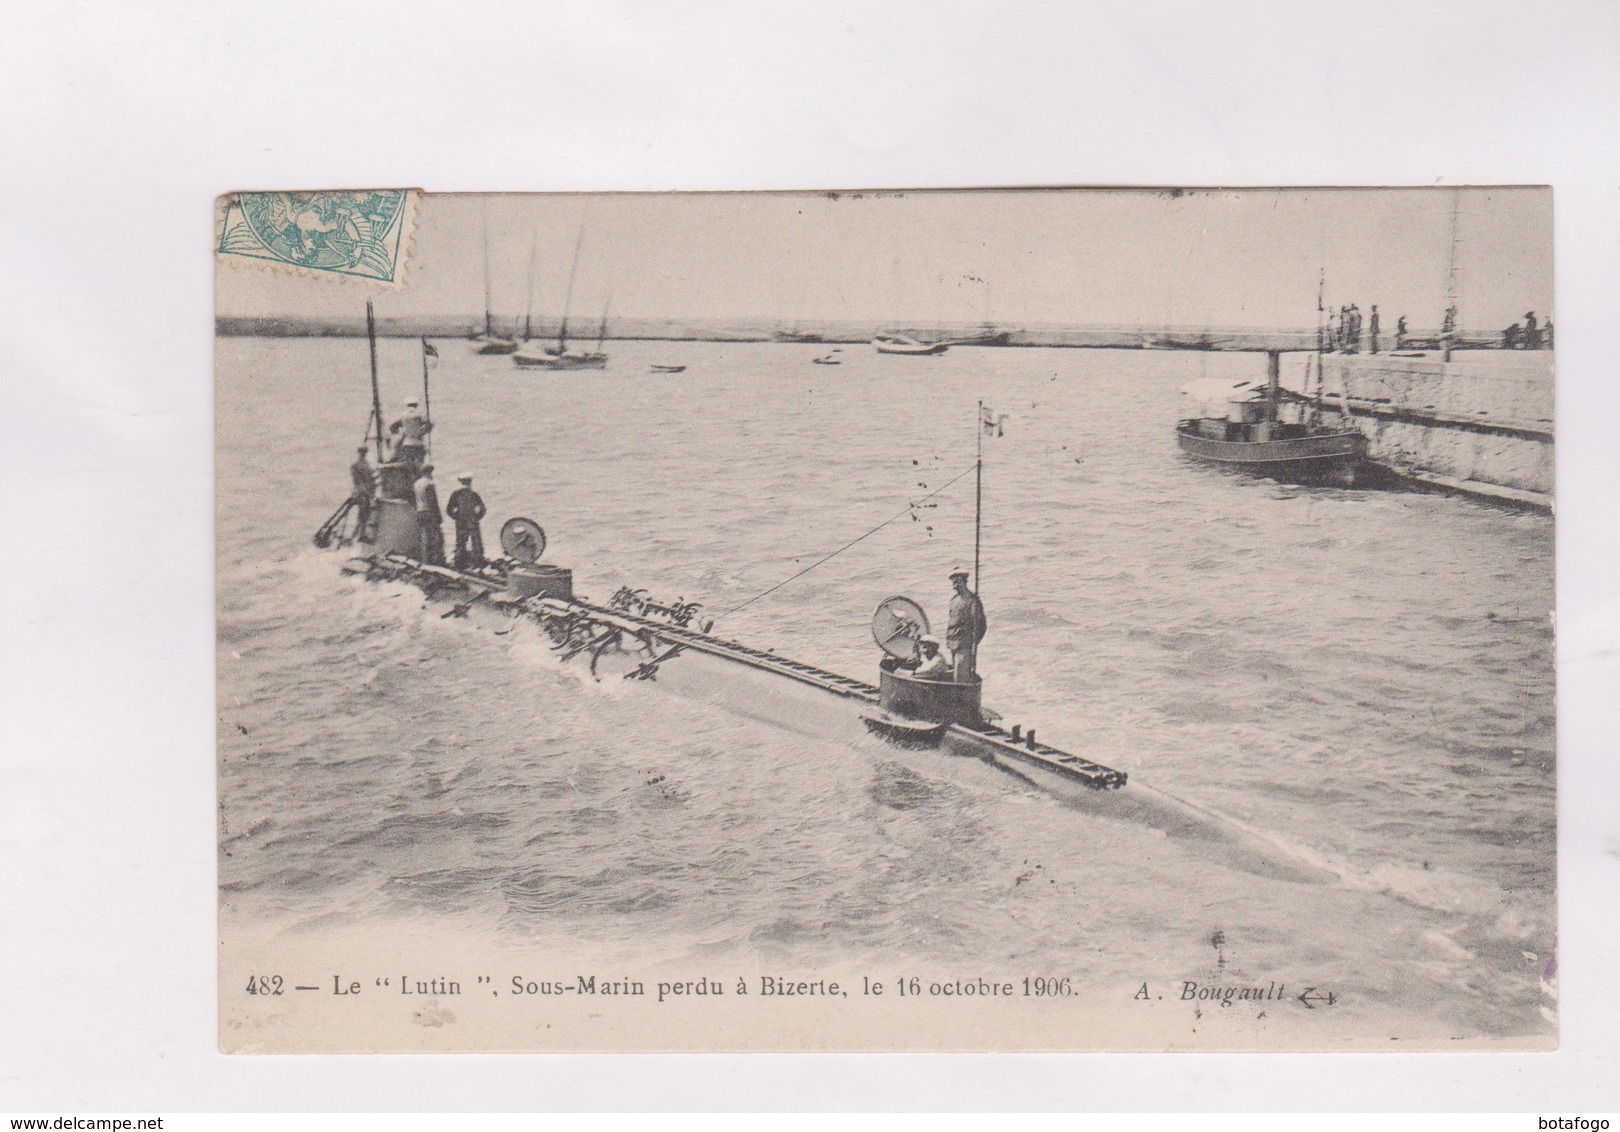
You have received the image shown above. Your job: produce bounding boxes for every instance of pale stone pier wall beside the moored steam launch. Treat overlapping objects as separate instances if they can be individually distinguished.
[1322,350,1554,505]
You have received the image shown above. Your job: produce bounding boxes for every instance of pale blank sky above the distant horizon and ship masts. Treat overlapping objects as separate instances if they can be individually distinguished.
[217,188,1554,330]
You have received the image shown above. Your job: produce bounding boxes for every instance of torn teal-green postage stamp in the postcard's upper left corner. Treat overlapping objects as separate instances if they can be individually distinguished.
[219,189,418,287]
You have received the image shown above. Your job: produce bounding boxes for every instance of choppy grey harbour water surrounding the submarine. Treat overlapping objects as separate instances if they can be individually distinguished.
[219,338,1555,1035]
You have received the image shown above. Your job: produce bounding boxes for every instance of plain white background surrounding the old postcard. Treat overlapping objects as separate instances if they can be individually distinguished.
[0,0,1620,1114]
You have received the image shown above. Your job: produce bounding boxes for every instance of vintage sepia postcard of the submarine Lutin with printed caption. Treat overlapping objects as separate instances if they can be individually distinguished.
[214,188,1558,1053]
